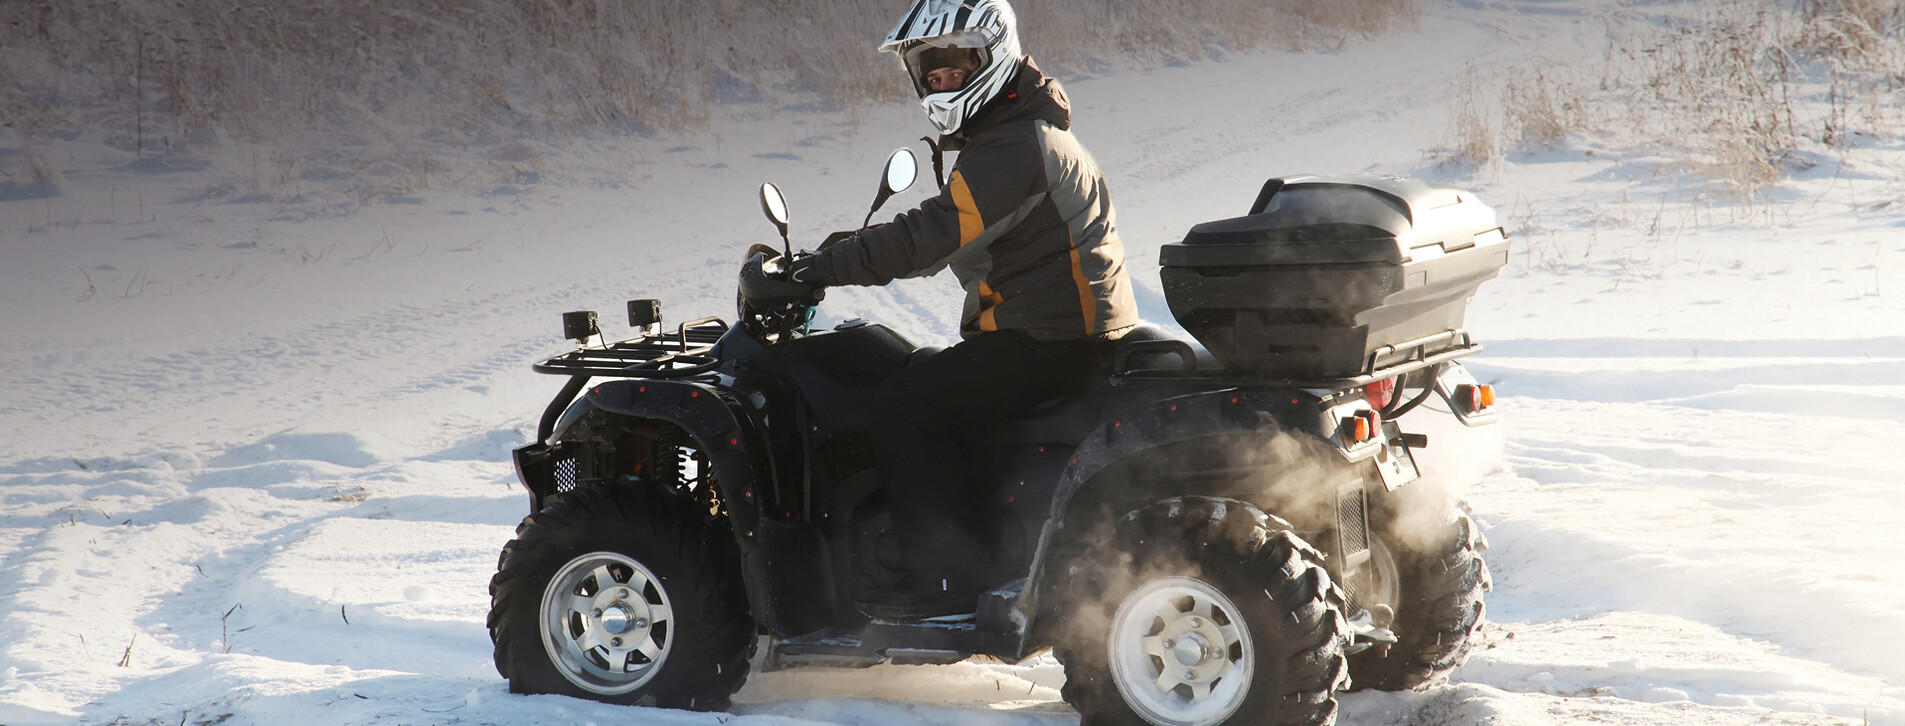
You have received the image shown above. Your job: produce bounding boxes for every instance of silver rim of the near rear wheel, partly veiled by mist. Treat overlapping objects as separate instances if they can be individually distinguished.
[1107,577,1255,726]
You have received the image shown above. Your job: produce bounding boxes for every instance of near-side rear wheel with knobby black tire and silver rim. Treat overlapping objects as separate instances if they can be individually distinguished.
[1057,497,1349,726]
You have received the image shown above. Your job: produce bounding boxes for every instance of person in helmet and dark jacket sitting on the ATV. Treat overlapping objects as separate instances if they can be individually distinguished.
[791,0,1137,614]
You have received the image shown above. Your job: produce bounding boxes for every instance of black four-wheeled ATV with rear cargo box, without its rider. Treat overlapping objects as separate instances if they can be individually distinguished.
[488,149,1507,726]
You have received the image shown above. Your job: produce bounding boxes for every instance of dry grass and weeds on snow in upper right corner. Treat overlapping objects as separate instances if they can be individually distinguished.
[1446,0,1905,202]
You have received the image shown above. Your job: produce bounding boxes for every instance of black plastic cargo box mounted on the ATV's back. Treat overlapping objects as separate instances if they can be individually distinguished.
[1158,173,1509,377]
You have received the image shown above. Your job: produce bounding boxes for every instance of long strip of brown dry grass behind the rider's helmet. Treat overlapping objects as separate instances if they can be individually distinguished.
[0,0,1415,156]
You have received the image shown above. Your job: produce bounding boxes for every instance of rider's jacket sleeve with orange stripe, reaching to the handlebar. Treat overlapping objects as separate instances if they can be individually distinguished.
[825,135,1046,284]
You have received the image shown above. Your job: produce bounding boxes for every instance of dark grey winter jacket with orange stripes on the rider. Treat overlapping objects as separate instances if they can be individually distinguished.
[823,59,1137,341]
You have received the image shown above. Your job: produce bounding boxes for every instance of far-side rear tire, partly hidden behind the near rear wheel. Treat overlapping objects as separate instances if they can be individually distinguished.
[1349,488,1492,690]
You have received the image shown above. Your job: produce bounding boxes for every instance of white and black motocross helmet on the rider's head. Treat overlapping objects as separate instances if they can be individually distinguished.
[880,0,1025,133]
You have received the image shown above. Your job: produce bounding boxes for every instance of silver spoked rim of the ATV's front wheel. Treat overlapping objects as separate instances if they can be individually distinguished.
[541,553,674,696]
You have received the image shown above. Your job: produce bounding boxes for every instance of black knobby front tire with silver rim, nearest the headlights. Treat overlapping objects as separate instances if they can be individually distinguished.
[490,480,754,711]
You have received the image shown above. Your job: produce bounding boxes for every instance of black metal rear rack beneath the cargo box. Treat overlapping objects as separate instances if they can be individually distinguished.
[1113,330,1482,391]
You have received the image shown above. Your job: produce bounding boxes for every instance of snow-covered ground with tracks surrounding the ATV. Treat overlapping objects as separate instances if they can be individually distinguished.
[0,0,1905,726]
